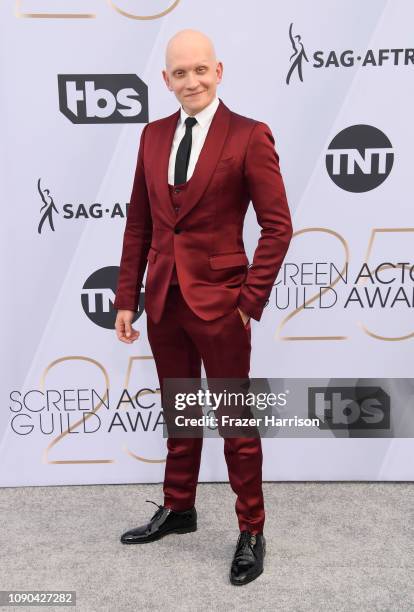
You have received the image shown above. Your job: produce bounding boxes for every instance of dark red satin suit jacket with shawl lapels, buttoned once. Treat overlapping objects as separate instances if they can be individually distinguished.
[114,99,292,323]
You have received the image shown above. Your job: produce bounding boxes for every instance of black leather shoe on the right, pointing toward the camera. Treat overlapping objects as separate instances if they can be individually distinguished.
[230,531,266,586]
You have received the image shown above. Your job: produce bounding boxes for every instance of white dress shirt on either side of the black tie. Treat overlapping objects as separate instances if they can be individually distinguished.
[168,96,220,185]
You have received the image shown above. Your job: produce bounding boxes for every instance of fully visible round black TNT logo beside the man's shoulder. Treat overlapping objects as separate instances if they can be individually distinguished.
[326,125,394,193]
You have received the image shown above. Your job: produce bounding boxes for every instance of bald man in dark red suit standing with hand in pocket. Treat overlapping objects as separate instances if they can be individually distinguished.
[114,30,292,585]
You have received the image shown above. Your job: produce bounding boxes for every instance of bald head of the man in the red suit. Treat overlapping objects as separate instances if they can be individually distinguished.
[162,30,223,116]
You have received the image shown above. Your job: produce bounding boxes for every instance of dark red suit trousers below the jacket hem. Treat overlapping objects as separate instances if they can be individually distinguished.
[147,285,265,533]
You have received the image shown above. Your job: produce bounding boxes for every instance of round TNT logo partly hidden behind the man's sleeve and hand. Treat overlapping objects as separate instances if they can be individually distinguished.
[81,266,144,329]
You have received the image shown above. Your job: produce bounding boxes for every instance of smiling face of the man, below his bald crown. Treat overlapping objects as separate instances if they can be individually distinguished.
[162,49,223,116]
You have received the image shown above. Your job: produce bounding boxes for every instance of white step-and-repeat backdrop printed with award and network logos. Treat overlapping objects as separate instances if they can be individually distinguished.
[0,0,414,486]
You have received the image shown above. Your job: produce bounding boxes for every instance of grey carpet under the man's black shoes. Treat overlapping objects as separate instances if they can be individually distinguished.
[0,482,414,612]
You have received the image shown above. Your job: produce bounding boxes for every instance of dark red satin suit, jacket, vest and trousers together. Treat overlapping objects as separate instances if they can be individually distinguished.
[114,100,292,533]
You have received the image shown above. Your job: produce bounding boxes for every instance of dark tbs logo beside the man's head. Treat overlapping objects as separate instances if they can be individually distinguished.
[58,74,148,123]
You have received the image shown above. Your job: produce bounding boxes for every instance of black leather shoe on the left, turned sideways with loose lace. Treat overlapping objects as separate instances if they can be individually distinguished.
[121,499,197,544]
